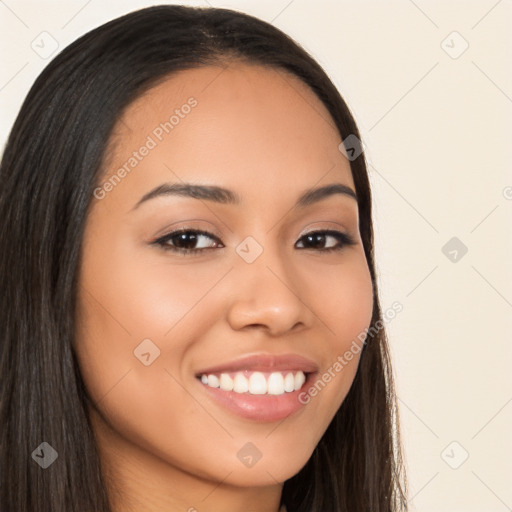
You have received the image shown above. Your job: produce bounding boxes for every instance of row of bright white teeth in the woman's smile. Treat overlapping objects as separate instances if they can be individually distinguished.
[201,371,306,395]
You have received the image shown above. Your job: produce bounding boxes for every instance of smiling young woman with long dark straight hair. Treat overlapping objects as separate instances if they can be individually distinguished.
[0,6,406,512]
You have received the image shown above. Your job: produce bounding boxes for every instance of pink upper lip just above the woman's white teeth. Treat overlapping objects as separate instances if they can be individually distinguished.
[196,354,318,376]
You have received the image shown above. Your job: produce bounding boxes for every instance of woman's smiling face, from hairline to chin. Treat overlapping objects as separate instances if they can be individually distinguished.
[76,64,373,502]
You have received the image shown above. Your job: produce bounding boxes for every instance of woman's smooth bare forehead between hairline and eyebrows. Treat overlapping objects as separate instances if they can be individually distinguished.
[100,62,353,210]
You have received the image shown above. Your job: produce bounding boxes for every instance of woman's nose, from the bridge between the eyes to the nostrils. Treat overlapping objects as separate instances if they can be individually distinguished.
[229,236,311,334]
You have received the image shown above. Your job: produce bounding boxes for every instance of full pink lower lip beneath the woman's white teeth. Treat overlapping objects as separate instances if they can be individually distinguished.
[199,373,315,422]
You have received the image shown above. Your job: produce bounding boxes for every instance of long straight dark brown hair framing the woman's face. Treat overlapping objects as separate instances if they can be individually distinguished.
[0,5,406,512]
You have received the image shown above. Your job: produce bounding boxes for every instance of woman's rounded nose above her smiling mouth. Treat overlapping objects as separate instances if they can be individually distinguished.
[227,243,315,337]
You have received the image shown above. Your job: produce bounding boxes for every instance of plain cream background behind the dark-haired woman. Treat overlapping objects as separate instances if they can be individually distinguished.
[0,0,512,512]
